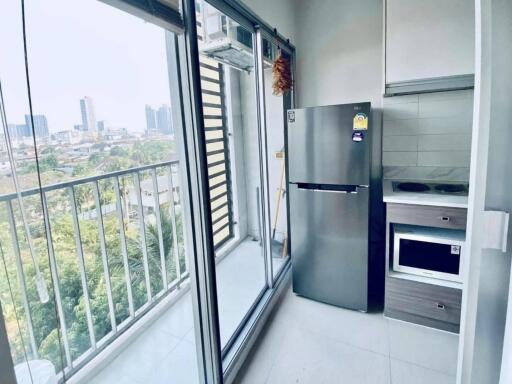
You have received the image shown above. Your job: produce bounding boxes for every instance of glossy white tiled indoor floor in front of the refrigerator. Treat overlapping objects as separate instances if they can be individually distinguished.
[237,289,458,384]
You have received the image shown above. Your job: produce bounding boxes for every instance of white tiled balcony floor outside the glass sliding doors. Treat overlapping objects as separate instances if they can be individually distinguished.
[88,240,283,384]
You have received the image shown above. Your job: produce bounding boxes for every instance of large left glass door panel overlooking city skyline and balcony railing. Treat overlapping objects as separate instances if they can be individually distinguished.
[0,0,198,384]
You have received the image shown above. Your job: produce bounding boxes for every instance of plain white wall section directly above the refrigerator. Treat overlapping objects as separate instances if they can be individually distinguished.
[295,0,383,107]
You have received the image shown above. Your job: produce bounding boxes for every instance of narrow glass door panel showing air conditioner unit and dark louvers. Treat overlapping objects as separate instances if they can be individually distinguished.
[197,2,267,349]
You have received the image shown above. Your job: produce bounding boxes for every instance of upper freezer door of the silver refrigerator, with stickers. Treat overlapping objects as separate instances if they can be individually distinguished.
[288,103,371,185]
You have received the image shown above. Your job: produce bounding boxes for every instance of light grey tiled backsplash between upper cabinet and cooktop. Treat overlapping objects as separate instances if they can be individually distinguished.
[382,90,473,181]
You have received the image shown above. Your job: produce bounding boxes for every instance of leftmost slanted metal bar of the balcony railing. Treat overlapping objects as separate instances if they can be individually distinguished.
[5,201,39,359]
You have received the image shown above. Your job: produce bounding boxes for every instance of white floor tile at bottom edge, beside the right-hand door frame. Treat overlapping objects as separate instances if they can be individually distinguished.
[391,359,455,384]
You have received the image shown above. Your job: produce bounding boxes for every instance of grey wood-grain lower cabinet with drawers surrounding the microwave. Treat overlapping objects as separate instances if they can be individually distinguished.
[384,203,467,333]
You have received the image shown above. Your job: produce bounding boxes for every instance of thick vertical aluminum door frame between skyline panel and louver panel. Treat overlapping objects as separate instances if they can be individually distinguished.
[175,0,223,384]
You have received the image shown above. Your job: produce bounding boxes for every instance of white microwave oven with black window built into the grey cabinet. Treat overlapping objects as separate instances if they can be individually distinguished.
[393,225,466,282]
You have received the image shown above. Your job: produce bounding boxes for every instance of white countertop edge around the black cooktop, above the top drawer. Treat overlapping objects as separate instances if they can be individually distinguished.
[382,179,468,208]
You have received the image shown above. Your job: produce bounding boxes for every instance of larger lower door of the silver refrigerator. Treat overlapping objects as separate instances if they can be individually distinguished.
[289,184,370,311]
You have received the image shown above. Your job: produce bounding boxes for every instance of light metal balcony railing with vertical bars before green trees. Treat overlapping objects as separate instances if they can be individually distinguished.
[0,161,188,374]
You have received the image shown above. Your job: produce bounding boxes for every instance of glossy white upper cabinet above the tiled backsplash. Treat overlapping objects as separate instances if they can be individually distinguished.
[386,0,475,84]
